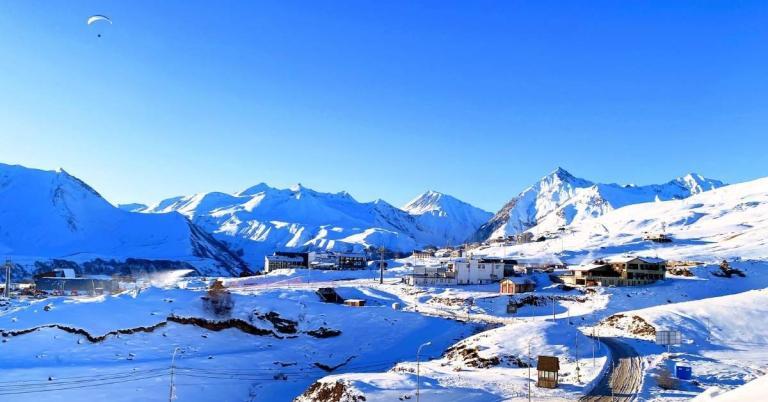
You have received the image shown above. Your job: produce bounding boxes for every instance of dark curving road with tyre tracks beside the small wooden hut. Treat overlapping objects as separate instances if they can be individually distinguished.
[581,338,643,402]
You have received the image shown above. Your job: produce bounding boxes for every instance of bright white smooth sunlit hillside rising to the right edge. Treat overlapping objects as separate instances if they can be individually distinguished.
[484,178,768,263]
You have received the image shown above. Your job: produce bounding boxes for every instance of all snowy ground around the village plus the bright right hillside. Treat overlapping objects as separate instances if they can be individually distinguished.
[0,176,768,402]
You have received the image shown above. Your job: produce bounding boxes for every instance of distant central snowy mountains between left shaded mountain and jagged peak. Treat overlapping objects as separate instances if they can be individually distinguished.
[136,183,490,267]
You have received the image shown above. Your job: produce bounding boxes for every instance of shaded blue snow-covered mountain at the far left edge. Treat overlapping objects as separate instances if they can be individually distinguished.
[0,164,244,274]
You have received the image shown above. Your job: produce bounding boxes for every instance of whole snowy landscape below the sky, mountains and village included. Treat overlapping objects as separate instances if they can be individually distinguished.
[0,165,768,402]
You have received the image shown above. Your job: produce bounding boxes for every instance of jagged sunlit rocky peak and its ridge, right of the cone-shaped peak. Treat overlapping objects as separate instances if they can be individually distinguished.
[472,168,724,241]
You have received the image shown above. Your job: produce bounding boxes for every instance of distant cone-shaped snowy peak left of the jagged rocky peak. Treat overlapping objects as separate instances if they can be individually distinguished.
[403,190,493,246]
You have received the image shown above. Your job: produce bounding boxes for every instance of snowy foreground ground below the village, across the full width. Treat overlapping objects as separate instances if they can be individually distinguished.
[0,261,768,401]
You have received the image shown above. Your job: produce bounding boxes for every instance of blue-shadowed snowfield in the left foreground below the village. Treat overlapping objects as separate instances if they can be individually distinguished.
[0,288,477,401]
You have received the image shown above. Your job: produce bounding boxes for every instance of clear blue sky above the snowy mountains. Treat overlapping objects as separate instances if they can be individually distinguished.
[0,0,768,210]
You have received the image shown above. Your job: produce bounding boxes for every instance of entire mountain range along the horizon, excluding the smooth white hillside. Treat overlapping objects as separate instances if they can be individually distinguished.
[0,164,724,275]
